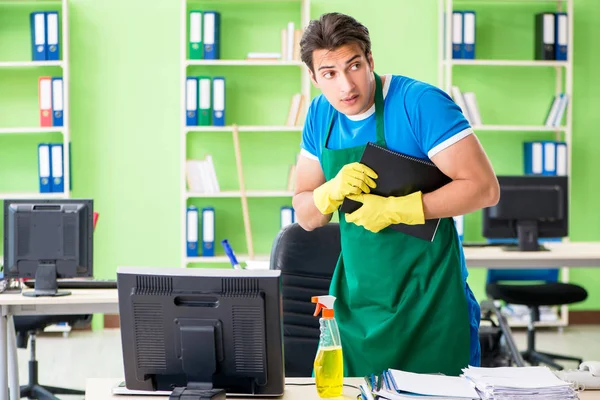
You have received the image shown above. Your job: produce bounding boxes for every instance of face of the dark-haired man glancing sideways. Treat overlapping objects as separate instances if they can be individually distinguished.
[310,43,375,115]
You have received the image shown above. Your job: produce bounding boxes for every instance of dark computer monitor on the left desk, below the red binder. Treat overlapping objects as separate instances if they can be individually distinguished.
[4,199,94,296]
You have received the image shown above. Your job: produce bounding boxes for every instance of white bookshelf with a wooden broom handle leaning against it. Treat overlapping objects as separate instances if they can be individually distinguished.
[179,0,311,268]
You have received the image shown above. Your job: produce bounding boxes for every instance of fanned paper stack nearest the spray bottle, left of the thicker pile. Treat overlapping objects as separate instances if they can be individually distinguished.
[369,369,479,400]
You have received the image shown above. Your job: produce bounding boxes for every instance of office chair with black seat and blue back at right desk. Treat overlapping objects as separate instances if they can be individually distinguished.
[486,269,587,370]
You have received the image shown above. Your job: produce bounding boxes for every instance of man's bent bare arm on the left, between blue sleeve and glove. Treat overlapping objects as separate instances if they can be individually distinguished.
[292,155,333,231]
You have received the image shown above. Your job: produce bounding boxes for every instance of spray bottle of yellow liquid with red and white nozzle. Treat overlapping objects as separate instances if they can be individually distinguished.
[312,296,344,398]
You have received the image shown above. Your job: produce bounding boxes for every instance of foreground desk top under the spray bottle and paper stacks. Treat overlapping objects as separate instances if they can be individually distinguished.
[85,378,600,400]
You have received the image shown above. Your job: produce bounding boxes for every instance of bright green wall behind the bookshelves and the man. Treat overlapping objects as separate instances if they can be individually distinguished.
[0,0,600,309]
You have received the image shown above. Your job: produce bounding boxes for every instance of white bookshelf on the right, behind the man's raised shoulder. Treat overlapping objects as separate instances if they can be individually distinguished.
[438,0,574,327]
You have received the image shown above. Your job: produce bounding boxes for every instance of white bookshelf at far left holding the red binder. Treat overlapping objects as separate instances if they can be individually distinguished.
[0,0,71,200]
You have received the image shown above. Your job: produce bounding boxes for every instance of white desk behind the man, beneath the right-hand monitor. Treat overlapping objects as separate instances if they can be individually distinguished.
[463,242,600,268]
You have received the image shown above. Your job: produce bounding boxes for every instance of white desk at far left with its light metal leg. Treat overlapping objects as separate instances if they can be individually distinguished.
[0,289,119,400]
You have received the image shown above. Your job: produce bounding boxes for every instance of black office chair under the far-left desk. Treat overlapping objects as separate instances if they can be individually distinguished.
[14,315,92,400]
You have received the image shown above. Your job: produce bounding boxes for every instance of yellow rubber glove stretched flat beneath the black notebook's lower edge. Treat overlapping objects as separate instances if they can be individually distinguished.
[346,192,425,232]
